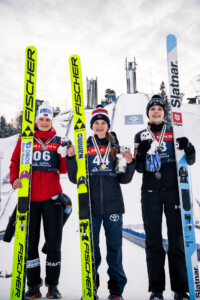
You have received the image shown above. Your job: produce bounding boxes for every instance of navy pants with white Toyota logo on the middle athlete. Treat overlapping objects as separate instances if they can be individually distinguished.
[92,213,127,293]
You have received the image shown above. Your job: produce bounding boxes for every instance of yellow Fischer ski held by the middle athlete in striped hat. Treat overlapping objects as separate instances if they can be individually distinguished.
[69,55,96,300]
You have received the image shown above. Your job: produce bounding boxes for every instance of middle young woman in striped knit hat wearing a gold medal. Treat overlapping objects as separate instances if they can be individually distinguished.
[67,106,135,300]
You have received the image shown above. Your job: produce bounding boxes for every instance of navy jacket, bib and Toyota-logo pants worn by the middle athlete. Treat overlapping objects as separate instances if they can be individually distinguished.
[67,135,135,293]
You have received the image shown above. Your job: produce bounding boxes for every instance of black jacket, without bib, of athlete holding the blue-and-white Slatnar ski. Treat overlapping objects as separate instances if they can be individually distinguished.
[135,124,196,190]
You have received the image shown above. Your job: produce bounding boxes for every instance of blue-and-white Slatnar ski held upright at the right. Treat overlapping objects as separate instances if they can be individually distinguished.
[167,34,200,300]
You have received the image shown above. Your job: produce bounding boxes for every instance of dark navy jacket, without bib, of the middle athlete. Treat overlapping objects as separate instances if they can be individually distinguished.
[67,137,135,215]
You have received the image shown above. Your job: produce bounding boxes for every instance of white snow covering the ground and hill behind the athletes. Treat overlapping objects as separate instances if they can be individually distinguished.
[0,94,200,300]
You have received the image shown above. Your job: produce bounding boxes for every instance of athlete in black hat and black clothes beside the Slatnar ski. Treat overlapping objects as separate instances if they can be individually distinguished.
[135,95,195,300]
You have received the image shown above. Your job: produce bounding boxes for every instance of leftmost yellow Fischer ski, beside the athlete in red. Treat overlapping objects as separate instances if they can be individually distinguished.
[10,46,37,300]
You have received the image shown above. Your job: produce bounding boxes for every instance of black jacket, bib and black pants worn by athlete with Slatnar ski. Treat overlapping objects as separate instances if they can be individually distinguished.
[135,123,195,293]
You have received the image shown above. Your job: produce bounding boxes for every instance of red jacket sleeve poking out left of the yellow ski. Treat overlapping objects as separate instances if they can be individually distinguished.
[9,139,21,185]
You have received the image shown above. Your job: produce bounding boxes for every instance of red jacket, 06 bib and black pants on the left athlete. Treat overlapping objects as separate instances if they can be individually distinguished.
[10,127,67,286]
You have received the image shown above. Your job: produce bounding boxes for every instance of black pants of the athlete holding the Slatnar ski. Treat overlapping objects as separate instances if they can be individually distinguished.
[142,189,188,292]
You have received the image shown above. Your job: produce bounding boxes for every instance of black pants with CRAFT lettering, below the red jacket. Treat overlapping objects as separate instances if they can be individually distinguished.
[27,199,63,285]
